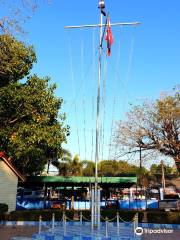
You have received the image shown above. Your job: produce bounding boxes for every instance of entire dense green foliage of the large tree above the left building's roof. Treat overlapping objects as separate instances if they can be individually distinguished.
[0,35,69,175]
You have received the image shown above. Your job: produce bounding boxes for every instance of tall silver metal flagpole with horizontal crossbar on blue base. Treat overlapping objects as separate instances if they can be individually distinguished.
[65,0,140,228]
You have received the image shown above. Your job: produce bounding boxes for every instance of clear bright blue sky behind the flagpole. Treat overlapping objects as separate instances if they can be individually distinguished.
[1,0,180,165]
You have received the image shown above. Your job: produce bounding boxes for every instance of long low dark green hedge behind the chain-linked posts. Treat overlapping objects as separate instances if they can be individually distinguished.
[0,209,180,224]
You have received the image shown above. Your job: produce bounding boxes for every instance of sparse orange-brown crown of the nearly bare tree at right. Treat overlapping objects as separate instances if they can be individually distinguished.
[115,87,180,171]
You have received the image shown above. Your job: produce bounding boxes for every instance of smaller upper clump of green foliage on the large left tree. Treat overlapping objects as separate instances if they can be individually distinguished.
[0,35,36,87]
